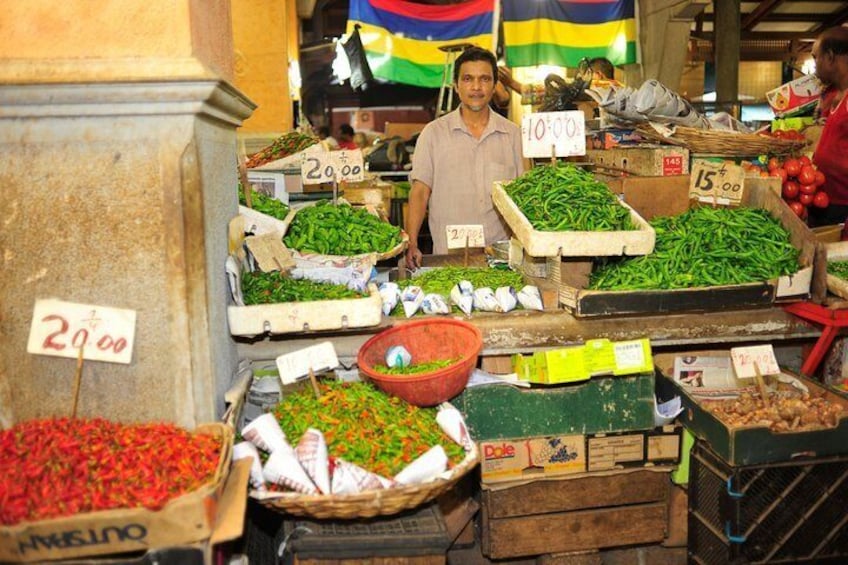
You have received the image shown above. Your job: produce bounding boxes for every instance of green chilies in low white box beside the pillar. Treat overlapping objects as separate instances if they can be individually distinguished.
[241,271,366,306]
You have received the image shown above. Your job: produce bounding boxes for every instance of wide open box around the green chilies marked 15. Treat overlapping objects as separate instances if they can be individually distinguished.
[548,175,825,317]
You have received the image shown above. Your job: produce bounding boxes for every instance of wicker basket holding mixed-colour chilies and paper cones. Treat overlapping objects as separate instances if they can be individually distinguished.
[251,444,480,519]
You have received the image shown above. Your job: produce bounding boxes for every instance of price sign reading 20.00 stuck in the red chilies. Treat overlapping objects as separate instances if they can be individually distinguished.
[27,298,136,364]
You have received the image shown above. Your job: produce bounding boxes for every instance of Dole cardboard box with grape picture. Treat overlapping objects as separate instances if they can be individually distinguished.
[480,434,586,483]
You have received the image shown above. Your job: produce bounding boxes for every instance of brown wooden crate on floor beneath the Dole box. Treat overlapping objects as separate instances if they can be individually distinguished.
[480,467,671,559]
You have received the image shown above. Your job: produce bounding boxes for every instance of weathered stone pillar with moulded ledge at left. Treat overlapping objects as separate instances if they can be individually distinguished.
[0,0,255,426]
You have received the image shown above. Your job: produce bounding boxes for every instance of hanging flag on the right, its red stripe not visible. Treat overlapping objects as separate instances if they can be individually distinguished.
[501,0,636,67]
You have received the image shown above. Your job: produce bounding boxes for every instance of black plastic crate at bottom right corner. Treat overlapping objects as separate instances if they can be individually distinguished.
[688,441,848,565]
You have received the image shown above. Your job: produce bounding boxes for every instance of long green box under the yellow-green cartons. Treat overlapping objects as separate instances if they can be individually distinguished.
[451,372,654,441]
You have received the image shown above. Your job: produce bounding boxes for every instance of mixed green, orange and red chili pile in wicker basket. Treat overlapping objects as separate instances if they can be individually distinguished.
[274,381,465,477]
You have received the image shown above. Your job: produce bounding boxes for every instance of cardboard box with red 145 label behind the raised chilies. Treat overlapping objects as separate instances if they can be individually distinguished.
[586,145,689,177]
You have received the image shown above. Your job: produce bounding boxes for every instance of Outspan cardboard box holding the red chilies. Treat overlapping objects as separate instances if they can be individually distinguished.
[0,423,235,563]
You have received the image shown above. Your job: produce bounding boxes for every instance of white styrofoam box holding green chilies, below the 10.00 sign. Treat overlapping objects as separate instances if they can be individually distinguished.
[492,182,656,257]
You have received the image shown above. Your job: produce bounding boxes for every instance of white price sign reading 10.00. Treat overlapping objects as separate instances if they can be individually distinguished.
[521,111,586,157]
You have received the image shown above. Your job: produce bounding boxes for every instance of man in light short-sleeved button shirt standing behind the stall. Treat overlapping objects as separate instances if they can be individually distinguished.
[406,47,524,269]
